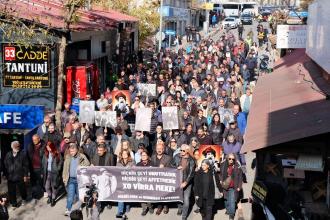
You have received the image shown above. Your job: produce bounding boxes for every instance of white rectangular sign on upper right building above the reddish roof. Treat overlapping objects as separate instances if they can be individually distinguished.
[276,25,307,49]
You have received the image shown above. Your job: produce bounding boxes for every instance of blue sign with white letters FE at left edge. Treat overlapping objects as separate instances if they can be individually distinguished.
[0,105,45,129]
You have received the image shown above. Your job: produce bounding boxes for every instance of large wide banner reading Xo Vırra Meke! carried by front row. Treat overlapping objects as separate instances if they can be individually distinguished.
[77,166,183,202]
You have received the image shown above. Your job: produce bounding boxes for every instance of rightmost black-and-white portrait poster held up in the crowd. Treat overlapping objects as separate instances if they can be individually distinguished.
[162,106,179,130]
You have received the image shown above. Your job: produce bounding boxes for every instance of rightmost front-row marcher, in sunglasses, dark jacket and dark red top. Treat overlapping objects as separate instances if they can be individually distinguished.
[220,153,243,220]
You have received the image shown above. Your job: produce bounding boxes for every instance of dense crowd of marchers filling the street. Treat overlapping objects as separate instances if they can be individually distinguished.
[1,25,272,220]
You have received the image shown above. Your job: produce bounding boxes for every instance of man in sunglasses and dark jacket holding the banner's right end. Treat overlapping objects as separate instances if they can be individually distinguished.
[171,144,196,220]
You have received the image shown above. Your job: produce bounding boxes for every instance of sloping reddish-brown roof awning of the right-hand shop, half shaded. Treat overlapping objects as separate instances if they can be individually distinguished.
[242,49,330,152]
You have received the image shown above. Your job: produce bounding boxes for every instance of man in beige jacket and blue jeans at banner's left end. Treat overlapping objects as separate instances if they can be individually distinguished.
[62,143,90,216]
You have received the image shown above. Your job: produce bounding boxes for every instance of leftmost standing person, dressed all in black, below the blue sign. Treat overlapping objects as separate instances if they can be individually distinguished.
[4,141,29,208]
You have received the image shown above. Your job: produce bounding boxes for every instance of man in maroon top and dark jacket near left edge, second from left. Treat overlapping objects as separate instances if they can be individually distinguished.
[27,134,46,199]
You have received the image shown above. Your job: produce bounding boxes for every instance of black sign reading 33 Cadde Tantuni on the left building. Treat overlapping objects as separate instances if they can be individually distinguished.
[2,44,51,89]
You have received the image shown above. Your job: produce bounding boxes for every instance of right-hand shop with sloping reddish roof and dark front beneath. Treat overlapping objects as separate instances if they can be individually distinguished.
[242,49,330,220]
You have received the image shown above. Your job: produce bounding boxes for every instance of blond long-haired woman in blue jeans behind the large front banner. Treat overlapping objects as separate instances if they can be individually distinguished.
[116,149,135,218]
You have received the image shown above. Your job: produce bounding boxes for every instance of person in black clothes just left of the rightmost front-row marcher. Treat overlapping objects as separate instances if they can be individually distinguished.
[194,159,222,220]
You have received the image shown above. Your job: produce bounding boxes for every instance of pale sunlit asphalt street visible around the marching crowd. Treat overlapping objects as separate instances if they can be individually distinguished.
[5,19,264,220]
